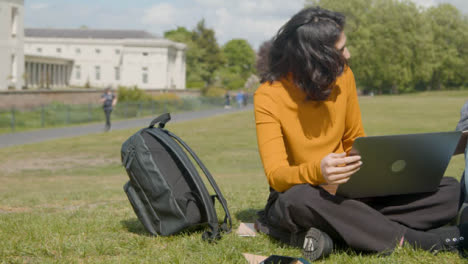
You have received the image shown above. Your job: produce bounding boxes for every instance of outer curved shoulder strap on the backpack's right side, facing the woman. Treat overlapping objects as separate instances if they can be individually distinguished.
[165,130,232,233]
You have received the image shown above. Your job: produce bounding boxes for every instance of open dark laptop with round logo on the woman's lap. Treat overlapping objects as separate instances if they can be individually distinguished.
[336,131,461,198]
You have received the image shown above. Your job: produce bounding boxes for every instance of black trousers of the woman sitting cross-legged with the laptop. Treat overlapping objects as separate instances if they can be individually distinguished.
[263,177,460,252]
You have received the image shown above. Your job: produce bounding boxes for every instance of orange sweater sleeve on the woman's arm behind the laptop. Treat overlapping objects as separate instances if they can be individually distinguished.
[342,68,366,153]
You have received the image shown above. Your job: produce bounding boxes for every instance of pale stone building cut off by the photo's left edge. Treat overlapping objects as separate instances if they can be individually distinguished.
[0,0,24,90]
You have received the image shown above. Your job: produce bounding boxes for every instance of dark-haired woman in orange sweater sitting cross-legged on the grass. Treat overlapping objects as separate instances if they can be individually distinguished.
[254,7,468,260]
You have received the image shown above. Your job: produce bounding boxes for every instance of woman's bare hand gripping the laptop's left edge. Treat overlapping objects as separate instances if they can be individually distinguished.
[320,153,362,184]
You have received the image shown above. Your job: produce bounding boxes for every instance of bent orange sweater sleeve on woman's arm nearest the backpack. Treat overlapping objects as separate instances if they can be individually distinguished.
[254,90,325,192]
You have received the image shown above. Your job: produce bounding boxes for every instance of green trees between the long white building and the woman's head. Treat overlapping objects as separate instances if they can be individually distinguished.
[164,20,256,94]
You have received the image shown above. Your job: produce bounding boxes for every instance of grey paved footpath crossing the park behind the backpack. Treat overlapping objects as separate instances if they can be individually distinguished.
[0,105,252,148]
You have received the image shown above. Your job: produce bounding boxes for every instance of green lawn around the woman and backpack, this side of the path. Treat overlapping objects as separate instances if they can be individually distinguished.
[0,92,468,263]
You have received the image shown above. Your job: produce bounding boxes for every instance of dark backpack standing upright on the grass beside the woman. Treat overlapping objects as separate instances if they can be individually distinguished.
[121,113,232,241]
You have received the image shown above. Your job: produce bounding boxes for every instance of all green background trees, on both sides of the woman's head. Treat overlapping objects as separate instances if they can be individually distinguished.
[164,0,468,94]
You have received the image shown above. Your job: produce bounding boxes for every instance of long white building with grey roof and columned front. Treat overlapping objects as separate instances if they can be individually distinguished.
[24,29,186,89]
